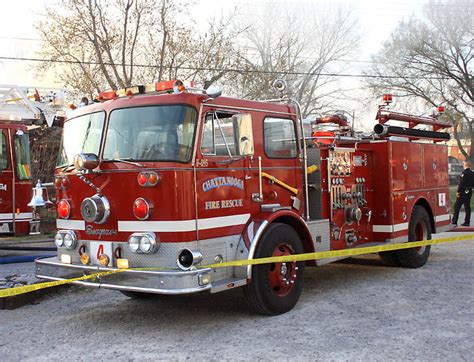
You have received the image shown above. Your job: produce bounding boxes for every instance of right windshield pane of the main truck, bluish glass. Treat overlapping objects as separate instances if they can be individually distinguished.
[103,105,197,162]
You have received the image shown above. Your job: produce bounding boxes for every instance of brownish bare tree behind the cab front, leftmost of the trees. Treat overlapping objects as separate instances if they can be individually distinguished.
[37,0,239,95]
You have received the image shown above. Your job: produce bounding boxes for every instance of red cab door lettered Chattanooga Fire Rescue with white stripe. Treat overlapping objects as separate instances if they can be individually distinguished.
[196,109,253,240]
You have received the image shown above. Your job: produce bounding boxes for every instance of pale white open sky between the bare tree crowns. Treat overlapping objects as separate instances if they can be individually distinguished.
[0,0,428,125]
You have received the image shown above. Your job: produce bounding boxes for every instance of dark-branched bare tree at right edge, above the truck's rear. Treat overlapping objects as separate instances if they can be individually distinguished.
[368,0,474,159]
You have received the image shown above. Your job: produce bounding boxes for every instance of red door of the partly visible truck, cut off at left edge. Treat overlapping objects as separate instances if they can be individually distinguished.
[0,128,15,233]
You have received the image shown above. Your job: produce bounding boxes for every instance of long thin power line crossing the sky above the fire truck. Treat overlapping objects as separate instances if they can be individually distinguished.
[0,56,448,80]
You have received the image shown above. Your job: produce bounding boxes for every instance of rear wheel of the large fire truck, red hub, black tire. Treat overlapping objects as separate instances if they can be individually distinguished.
[396,205,431,268]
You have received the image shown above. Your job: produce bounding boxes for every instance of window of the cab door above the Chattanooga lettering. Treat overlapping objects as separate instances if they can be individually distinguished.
[201,112,253,157]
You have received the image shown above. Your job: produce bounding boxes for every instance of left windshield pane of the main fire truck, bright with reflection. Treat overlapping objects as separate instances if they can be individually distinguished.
[57,112,105,167]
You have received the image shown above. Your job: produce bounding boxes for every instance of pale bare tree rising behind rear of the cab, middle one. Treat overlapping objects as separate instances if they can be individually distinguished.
[233,3,359,116]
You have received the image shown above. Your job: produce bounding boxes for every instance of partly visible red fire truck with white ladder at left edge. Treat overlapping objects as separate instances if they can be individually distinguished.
[0,85,64,235]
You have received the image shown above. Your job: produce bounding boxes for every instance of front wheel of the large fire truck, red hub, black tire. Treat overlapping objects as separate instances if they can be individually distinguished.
[245,223,305,315]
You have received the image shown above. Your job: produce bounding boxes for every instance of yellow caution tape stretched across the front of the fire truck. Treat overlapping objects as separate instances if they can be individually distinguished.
[0,234,474,298]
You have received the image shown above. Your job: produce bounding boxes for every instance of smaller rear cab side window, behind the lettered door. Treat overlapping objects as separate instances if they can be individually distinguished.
[263,117,298,158]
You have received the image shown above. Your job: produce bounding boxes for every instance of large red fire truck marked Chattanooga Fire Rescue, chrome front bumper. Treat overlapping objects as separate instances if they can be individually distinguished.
[36,81,450,315]
